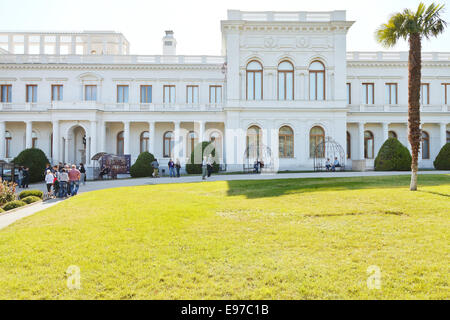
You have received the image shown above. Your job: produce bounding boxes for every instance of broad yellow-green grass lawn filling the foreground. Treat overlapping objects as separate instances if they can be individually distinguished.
[0,175,450,299]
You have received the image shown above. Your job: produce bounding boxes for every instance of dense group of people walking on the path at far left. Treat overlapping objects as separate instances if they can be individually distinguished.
[44,163,86,198]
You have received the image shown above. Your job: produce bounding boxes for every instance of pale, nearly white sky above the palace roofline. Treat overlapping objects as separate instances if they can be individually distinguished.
[0,0,450,55]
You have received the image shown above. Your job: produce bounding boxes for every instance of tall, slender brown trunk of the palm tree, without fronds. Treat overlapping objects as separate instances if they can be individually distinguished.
[408,33,422,191]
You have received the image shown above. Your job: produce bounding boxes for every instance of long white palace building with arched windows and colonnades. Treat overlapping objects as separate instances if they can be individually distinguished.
[0,10,450,175]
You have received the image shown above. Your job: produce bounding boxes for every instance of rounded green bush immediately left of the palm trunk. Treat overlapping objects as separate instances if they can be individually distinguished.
[375,138,412,171]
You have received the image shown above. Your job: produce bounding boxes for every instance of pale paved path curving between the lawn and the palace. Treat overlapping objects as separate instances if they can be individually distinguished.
[0,171,450,229]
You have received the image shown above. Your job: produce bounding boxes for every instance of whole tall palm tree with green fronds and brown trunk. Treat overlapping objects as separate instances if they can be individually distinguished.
[375,3,447,191]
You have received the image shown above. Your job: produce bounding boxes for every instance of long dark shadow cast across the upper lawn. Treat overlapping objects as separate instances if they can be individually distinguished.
[227,175,450,200]
